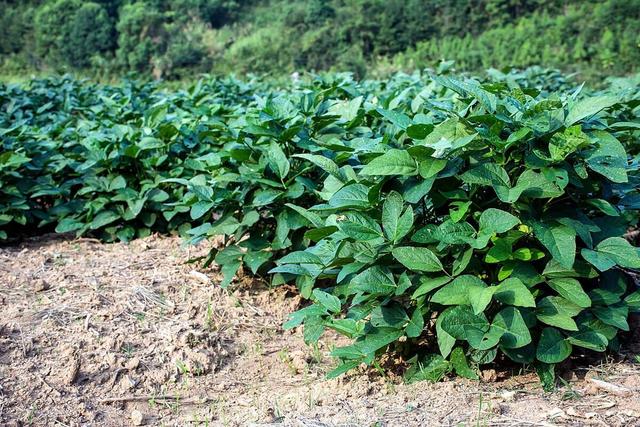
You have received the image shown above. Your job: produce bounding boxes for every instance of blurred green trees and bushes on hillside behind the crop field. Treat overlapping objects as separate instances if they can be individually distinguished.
[0,0,640,79]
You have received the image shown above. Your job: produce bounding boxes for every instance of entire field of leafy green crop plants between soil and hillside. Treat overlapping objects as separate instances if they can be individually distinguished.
[0,68,640,387]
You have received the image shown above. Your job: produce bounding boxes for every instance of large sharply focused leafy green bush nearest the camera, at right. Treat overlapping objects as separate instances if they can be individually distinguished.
[271,77,640,381]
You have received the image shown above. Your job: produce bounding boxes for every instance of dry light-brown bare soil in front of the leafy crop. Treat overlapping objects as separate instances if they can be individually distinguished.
[0,236,640,427]
